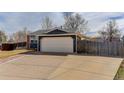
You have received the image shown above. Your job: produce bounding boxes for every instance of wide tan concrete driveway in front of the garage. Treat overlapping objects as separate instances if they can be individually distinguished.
[0,54,122,80]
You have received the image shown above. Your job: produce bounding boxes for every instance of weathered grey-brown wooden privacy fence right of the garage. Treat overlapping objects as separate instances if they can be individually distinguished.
[77,40,124,57]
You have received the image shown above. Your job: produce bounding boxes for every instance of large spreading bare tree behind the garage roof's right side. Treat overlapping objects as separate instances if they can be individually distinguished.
[64,13,88,33]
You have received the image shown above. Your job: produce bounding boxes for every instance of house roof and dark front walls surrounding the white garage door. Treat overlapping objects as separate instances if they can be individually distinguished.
[28,29,79,52]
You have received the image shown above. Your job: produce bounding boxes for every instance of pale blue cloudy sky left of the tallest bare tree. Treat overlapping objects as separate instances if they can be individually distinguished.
[0,12,62,34]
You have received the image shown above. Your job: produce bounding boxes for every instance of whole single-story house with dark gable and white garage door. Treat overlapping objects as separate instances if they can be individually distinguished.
[27,28,81,53]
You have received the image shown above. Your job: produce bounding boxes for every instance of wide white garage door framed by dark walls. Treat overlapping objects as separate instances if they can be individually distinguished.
[40,37,73,53]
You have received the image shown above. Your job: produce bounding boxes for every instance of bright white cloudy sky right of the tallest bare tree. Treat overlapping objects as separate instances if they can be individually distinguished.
[80,12,124,35]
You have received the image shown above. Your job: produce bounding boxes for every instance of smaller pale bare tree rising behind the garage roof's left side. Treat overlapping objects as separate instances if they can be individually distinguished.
[41,16,53,29]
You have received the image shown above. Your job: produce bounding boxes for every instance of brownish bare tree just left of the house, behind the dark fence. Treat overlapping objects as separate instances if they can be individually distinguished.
[11,27,30,42]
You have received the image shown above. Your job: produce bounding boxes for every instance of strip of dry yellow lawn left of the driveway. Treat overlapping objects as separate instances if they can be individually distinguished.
[0,49,31,59]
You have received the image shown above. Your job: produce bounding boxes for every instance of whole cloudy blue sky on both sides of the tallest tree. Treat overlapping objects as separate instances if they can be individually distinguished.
[0,12,124,36]
